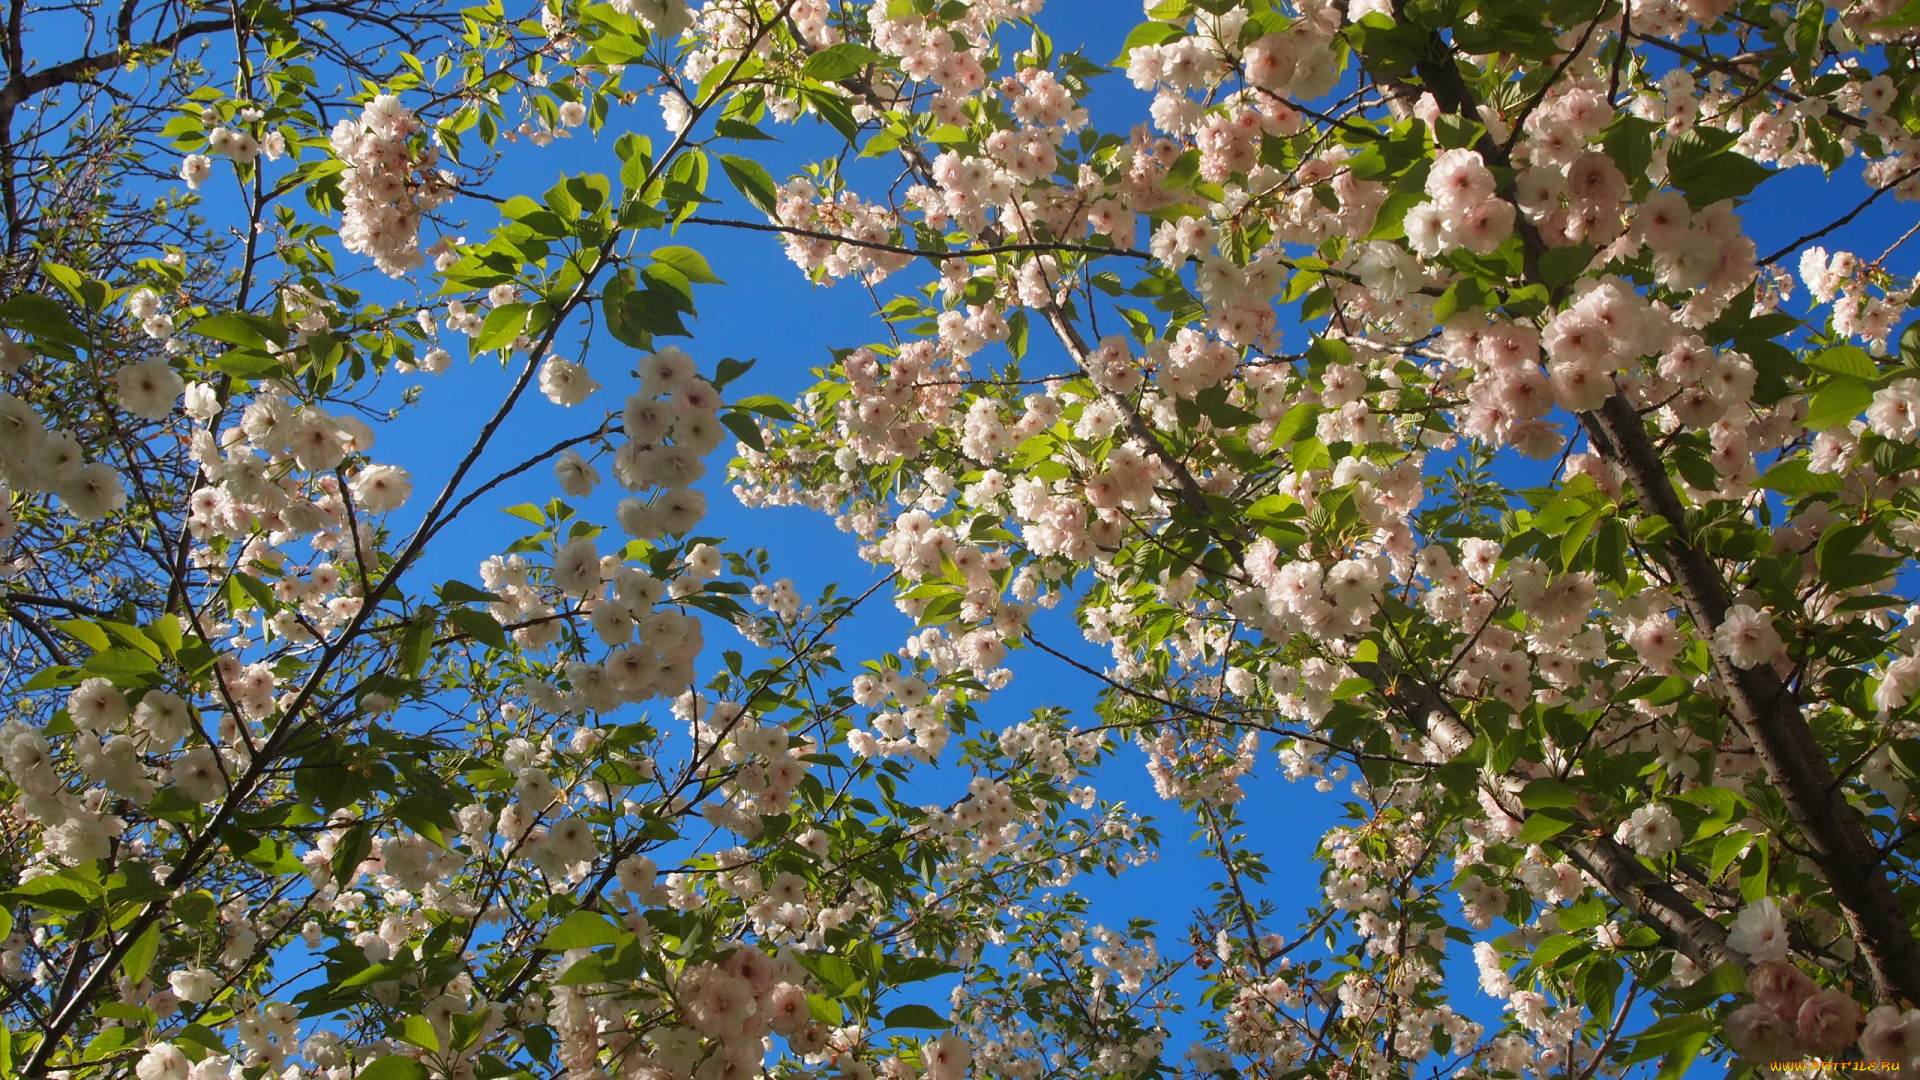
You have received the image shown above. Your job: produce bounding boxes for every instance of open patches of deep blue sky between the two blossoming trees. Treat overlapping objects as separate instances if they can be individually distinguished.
[353,0,1344,1055]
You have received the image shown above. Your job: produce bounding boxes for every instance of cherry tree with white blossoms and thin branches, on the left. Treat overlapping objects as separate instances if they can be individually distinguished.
[0,2,1146,1080]
